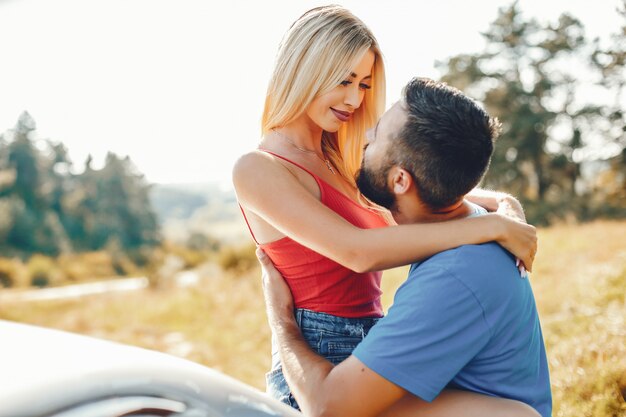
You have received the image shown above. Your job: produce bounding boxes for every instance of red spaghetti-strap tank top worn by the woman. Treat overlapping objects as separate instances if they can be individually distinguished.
[242,151,387,317]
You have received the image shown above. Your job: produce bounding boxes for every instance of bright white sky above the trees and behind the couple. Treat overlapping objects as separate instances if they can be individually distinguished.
[0,0,620,184]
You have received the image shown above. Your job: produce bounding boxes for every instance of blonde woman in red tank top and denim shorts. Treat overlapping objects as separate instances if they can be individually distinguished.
[233,6,536,408]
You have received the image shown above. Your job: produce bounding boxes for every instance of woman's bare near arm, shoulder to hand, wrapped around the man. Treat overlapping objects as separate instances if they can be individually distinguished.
[233,152,536,272]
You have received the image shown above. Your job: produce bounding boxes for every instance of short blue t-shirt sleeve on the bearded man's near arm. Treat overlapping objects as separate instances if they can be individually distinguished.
[354,265,490,401]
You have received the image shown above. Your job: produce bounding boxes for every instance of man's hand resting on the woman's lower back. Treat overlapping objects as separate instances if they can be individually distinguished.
[256,248,294,330]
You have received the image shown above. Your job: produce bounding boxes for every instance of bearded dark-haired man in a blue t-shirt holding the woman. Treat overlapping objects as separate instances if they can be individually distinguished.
[258,79,551,417]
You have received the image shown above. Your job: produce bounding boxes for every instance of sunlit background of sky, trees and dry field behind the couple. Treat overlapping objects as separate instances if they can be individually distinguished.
[0,0,626,417]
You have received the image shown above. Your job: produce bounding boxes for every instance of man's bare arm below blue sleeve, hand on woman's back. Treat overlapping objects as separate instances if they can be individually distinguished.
[257,250,406,417]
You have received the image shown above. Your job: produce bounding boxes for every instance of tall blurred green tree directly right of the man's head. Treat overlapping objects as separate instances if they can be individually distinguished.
[438,2,623,223]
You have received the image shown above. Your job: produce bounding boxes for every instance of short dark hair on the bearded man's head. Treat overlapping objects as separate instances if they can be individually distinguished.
[391,78,500,210]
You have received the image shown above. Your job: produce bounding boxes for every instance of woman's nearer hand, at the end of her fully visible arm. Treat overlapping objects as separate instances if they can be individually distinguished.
[490,213,537,271]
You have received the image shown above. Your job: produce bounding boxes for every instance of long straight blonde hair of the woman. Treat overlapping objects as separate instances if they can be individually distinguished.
[262,5,385,187]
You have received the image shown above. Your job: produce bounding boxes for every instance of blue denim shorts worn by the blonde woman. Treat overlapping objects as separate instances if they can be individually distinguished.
[265,309,380,410]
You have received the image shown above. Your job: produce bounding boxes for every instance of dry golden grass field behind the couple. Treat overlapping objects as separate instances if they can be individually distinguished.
[0,221,626,417]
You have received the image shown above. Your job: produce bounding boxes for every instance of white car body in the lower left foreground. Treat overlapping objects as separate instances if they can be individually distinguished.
[0,320,302,417]
